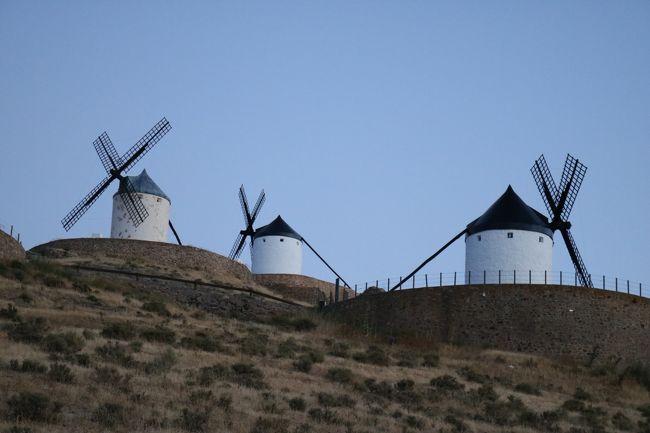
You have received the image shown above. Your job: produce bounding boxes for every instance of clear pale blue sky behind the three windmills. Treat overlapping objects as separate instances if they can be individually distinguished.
[0,0,650,283]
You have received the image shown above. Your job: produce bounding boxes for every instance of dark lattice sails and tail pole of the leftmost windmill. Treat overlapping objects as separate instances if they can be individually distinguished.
[61,117,181,244]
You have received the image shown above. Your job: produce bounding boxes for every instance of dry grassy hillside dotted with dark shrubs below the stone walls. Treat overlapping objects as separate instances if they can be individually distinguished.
[0,261,650,433]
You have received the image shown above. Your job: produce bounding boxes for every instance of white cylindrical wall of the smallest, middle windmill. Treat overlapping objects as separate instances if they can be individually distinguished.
[251,236,302,275]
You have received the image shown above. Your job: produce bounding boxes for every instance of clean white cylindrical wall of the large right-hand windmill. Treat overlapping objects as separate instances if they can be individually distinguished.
[465,230,553,284]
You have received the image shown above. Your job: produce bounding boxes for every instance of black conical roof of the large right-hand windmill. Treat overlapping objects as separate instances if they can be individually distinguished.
[467,185,553,237]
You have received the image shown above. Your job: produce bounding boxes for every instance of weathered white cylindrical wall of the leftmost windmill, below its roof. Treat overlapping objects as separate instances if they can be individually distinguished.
[111,193,171,242]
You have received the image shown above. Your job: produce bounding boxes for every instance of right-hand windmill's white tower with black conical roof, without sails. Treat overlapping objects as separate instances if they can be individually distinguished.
[465,186,553,284]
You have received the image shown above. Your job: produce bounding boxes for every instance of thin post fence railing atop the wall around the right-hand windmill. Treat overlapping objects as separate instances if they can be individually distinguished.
[353,270,650,298]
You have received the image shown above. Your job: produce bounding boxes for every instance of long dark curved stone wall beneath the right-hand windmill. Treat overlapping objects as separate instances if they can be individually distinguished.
[325,285,650,366]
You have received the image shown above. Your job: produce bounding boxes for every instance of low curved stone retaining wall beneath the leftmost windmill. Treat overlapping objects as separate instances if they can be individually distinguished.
[31,238,258,287]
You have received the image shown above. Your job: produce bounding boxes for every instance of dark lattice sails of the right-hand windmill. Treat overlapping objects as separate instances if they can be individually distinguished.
[530,154,593,287]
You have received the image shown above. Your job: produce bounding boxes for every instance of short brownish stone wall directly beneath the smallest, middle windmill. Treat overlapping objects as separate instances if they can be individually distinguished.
[253,274,354,305]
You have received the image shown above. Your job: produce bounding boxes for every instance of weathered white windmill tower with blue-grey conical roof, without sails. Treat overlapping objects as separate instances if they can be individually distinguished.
[111,170,171,242]
